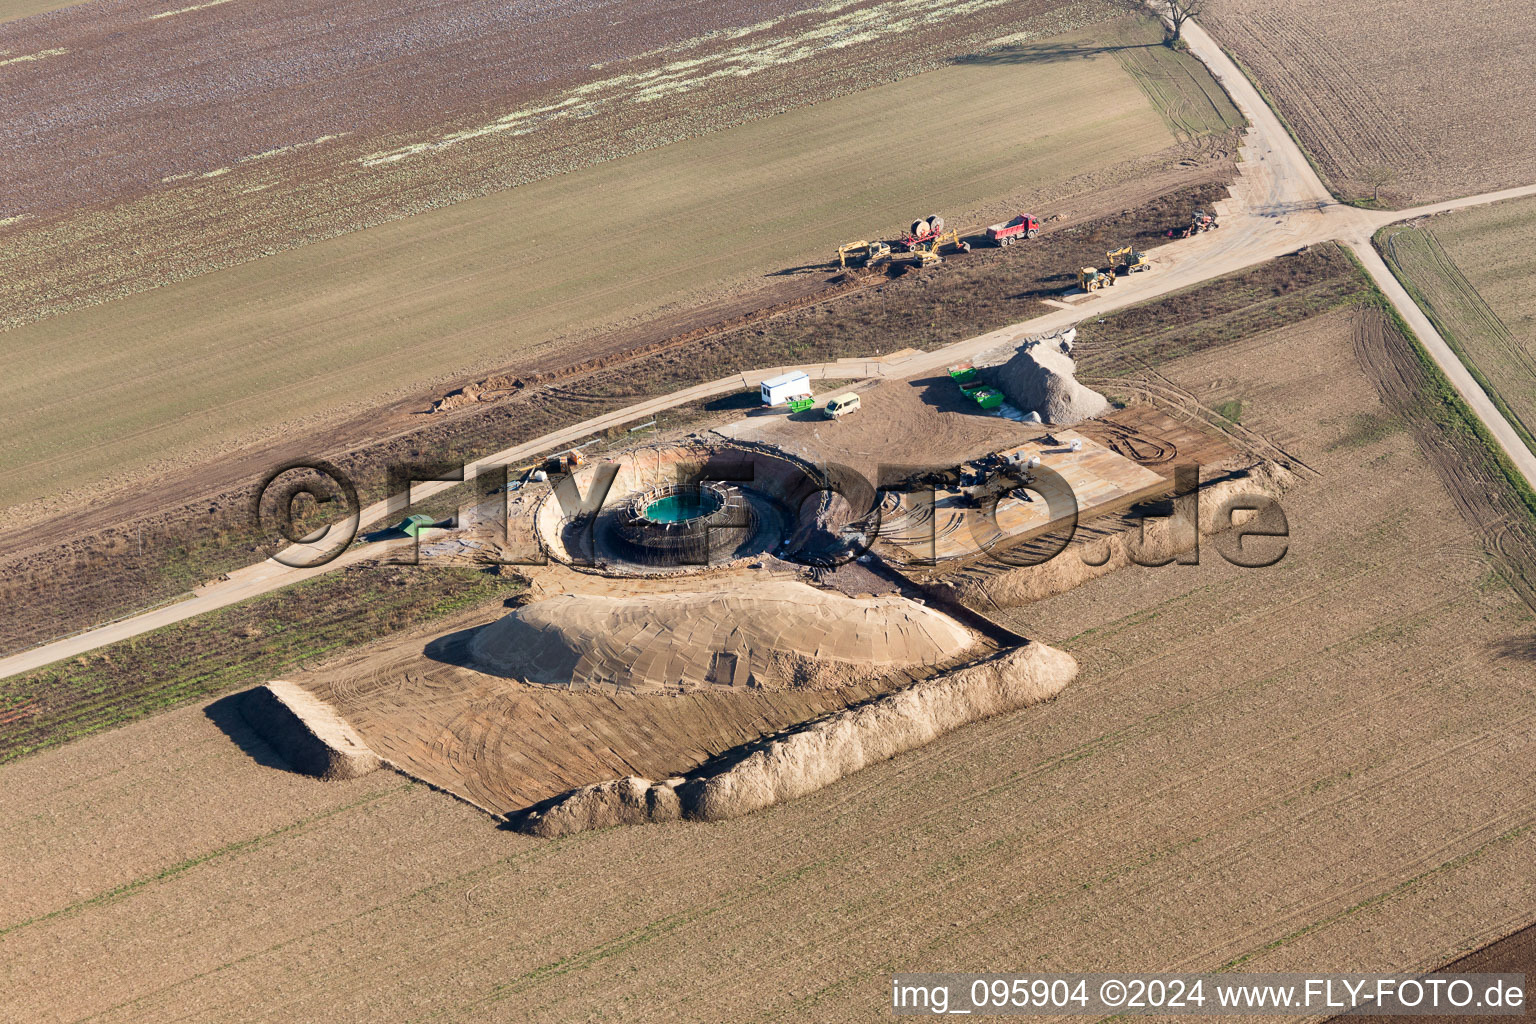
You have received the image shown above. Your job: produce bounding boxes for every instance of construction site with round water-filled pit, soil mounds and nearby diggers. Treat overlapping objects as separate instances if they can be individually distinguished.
[230,210,1287,837]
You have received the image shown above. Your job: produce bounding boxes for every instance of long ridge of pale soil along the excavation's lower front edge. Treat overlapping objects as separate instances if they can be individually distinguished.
[508,643,1077,838]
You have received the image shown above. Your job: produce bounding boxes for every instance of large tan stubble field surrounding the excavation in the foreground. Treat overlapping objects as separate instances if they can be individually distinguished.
[0,263,1536,1021]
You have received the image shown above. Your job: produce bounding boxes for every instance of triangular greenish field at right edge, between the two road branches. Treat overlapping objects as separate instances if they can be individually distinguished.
[1376,200,1536,450]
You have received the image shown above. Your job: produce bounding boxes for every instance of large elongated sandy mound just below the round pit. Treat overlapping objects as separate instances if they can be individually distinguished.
[472,580,972,691]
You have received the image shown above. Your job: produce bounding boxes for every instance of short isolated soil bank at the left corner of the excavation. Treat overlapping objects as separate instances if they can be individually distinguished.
[240,679,382,780]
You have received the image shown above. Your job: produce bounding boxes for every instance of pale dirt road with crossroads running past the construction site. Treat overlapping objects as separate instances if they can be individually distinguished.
[0,11,1536,679]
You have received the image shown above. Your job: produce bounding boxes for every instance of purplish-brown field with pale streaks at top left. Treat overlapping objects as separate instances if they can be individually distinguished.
[0,0,1120,324]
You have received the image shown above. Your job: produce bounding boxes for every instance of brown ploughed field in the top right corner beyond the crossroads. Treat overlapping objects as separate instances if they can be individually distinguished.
[1201,0,1536,207]
